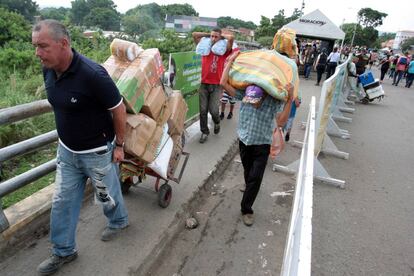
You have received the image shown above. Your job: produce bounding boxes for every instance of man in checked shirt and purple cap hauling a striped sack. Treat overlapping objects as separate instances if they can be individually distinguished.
[220,52,293,226]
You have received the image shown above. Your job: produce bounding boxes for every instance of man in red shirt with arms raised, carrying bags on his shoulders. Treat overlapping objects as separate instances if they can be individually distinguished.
[192,28,234,143]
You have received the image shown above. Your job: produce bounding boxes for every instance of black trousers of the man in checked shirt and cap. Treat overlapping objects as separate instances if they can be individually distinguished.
[239,141,270,215]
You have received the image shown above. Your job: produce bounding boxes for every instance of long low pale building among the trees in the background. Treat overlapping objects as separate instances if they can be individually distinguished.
[165,15,217,33]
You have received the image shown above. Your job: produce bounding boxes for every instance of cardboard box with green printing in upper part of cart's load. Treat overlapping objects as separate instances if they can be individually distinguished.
[116,59,151,114]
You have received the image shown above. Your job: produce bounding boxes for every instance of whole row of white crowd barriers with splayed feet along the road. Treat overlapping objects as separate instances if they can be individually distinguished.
[273,56,353,276]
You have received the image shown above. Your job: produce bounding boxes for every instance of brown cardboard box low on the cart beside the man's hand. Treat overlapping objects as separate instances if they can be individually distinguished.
[125,114,162,163]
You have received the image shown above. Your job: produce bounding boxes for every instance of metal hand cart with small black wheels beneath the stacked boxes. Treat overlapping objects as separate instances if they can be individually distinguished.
[119,137,190,208]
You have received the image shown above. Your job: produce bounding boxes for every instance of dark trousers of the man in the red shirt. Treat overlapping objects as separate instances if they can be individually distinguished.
[199,83,220,135]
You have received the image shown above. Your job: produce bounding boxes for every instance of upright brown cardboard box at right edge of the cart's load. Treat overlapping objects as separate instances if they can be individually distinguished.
[168,91,188,136]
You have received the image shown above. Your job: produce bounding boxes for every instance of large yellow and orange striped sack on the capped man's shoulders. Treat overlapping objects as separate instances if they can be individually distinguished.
[229,50,299,101]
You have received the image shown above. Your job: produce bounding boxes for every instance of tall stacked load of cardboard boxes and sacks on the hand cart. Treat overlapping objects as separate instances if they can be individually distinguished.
[103,39,188,179]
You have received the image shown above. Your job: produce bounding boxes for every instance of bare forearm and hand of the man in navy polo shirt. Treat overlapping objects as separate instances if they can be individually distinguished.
[111,103,126,163]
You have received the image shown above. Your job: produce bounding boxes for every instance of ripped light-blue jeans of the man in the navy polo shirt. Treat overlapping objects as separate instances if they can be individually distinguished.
[50,144,128,256]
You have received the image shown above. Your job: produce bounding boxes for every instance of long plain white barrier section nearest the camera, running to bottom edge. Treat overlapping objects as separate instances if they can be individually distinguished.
[276,97,316,276]
